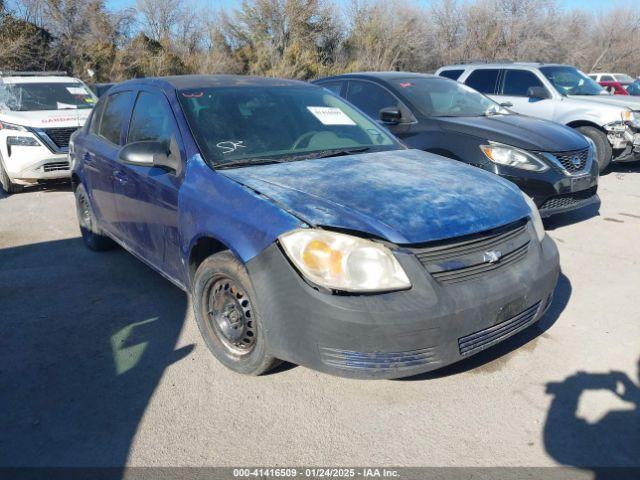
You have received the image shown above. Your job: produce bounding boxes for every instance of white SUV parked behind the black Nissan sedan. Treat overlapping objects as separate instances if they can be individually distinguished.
[436,63,640,172]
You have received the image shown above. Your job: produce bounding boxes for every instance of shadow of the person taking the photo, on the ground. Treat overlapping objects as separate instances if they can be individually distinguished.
[544,360,640,479]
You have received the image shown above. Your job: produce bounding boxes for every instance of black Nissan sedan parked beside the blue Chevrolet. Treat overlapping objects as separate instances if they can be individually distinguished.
[313,72,600,217]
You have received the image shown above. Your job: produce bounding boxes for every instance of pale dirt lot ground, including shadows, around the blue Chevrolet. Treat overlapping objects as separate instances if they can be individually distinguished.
[0,165,640,466]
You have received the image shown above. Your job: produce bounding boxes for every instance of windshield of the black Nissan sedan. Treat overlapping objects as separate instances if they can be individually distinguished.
[392,78,509,117]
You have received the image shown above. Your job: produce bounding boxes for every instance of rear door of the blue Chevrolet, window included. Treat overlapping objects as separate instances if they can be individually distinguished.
[77,91,133,238]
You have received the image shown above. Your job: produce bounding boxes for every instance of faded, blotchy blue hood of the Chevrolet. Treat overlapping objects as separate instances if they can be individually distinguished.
[219,150,530,244]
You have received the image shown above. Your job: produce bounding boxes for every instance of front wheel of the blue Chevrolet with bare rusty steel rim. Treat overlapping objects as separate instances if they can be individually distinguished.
[191,251,280,375]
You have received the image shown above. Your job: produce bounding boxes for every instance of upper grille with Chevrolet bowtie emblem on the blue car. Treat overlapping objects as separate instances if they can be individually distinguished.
[413,220,530,284]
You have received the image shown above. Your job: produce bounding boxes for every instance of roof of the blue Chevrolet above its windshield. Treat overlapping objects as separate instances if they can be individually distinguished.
[118,75,310,90]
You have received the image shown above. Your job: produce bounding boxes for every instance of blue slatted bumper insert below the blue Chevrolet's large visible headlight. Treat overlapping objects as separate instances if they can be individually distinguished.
[320,347,438,370]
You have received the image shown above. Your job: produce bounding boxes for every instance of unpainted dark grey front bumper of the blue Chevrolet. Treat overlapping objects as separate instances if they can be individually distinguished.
[247,232,559,378]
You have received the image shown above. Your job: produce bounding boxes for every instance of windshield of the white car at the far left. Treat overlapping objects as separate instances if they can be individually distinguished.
[0,82,96,111]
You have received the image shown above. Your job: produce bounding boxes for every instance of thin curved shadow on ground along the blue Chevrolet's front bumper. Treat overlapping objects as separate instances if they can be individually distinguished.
[398,273,571,381]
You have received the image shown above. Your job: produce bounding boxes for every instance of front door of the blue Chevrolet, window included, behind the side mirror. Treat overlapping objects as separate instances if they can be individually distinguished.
[114,87,185,279]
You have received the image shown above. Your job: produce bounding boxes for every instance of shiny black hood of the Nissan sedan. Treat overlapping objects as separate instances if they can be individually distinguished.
[438,115,589,152]
